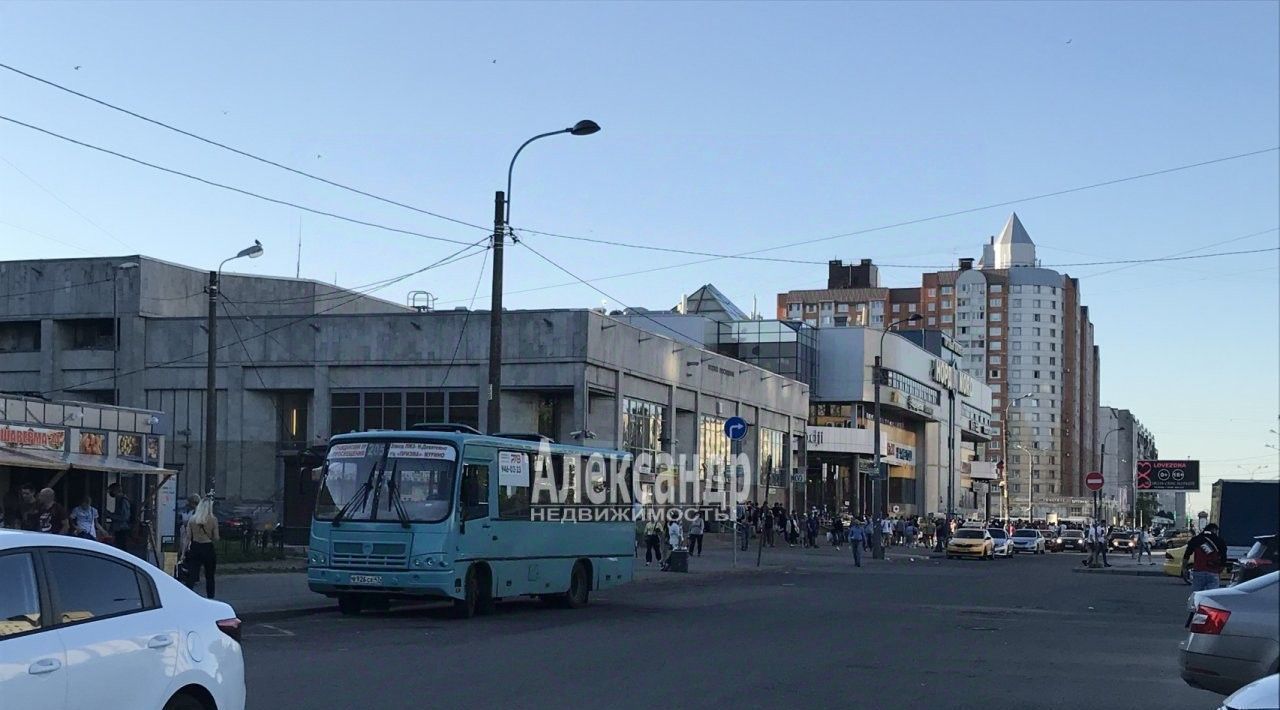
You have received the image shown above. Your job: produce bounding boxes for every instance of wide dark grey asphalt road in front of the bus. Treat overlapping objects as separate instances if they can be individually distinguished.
[244,554,1221,710]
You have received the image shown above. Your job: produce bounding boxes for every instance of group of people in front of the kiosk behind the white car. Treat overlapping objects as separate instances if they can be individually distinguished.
[0,484,137,550]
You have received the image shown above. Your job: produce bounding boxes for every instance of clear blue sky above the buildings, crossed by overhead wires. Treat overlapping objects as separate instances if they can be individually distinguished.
[0,3,1280,511]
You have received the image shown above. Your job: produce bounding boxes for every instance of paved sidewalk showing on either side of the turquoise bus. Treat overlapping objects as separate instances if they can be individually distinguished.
[217,533,901,622]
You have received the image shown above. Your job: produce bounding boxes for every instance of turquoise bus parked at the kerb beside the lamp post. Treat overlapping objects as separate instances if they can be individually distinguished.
[307,425,635,618]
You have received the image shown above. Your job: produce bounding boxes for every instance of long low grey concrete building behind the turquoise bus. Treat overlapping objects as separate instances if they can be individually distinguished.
[0,256,809,539]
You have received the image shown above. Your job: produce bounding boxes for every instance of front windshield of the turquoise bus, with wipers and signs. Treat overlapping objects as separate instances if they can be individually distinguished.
[316,441,457,523]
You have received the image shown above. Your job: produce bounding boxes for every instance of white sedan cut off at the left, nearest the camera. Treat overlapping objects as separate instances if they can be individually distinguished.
[0,530,244,710]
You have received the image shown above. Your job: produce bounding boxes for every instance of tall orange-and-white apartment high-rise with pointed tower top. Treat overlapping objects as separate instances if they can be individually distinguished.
[777,214,1101,518]
